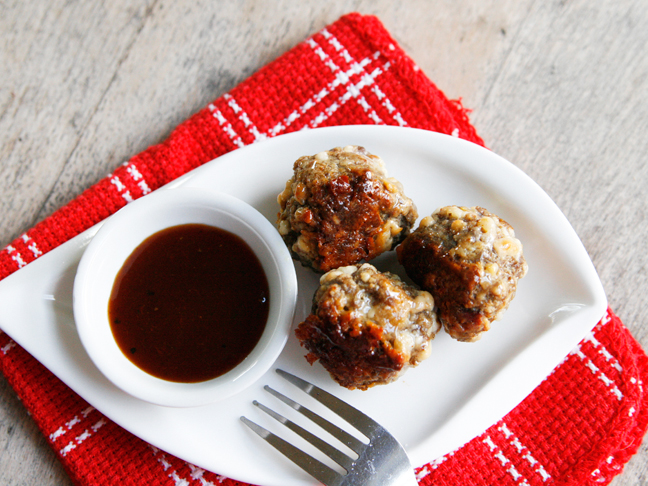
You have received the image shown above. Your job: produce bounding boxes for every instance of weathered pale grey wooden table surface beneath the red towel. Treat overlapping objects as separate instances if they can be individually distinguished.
[0,0,648,486]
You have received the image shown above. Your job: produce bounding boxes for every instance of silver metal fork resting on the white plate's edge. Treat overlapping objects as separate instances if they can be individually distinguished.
[241,369,418,486]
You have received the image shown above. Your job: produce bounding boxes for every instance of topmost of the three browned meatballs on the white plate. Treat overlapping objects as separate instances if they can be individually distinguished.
[277,146,418,273]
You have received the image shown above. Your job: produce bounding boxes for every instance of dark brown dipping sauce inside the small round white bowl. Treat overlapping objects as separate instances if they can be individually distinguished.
[108,224,270,383]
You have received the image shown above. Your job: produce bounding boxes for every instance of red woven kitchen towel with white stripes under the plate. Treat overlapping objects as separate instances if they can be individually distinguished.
[0,14,648,486]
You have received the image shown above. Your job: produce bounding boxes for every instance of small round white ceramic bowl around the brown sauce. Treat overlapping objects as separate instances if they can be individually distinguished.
[73,188,297,407]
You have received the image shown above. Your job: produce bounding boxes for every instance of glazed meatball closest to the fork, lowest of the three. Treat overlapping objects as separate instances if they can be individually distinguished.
[296,263,441,390]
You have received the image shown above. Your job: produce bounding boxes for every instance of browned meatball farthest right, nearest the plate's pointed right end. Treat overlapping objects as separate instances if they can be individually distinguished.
[396,206,527,342]
